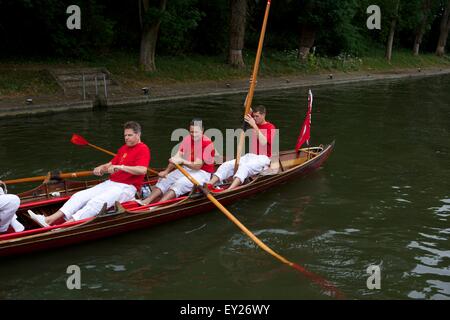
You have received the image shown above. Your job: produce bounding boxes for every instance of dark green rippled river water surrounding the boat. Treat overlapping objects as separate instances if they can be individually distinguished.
[0,76,450,299]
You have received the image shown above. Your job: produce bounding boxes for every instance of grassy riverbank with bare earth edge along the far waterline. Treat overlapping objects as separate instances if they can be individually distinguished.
[0,53,450,116]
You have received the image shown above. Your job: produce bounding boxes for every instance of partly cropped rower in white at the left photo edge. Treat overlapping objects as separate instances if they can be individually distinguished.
[0,180,25,233]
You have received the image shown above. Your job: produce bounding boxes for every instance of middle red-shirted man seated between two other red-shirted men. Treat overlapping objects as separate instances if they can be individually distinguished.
[140,119,215,205]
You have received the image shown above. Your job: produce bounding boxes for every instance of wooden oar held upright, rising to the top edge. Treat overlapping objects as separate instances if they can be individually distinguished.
[234,0,271,172]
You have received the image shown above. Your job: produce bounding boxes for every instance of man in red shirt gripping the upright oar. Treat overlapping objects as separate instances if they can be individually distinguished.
[208,105,276,189]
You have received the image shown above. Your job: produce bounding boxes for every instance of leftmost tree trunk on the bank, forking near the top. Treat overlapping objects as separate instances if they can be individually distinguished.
[139,0,167,71]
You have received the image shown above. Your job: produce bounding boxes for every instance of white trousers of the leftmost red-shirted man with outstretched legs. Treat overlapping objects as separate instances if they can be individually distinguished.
[60,180,136,220]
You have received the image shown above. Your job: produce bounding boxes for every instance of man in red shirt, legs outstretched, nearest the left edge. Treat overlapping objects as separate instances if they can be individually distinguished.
[28,121,150,227]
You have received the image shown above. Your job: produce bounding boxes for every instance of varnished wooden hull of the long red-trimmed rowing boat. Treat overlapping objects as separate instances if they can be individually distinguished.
[0,142,334,256]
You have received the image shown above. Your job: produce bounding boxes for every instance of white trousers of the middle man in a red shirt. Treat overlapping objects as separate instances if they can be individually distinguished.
[155,166,211,198]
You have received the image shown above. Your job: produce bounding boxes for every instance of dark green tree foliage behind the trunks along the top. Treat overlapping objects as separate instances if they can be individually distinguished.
[0,0,448,59]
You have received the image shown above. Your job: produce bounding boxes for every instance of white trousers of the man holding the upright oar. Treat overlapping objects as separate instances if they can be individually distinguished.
[214,153,270,183]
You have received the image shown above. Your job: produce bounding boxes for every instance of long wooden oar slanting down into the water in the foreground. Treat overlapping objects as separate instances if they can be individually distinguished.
[175,164,344,299]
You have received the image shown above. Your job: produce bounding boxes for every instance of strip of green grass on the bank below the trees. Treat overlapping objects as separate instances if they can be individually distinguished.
[0,50,450,97]
